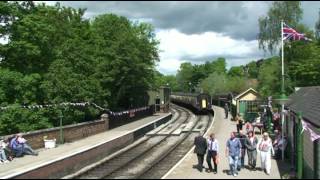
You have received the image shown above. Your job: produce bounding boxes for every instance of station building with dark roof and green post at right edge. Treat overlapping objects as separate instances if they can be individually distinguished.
[284,86,320,179]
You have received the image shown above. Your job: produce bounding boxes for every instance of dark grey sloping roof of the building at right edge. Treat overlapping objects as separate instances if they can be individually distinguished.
[286,86,320,127]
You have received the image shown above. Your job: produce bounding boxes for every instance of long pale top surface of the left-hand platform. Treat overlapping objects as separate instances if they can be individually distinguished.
[0,113,168,179]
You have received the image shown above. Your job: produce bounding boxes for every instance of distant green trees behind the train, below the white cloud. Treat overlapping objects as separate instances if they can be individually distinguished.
[156,58,258,95]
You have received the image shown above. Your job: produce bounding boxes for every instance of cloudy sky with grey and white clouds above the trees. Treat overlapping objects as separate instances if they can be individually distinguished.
[33,1,320,74]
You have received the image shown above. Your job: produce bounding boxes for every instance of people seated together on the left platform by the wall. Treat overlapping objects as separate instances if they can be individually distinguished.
[0,134,38,164]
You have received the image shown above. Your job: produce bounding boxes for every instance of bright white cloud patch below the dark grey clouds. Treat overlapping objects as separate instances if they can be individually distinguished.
[157,29,264,74]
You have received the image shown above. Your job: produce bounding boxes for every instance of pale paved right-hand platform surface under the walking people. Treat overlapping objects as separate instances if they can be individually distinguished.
[165,107,288,179]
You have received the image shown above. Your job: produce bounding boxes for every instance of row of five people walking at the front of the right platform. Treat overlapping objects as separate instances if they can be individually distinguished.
[194,131,275,177]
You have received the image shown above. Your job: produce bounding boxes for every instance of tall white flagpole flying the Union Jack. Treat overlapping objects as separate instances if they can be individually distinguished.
[281,20,285,161]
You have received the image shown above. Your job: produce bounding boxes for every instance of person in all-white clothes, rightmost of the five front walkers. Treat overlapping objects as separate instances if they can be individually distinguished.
[258,132,274,175]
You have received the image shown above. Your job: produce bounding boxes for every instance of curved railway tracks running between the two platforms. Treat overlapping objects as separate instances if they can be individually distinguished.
[73,106,210,179]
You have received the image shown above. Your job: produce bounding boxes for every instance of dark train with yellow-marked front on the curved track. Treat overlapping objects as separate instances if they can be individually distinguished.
[170,92,213,114]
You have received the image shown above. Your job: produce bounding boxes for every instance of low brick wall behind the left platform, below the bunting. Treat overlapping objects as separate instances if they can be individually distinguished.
[4,114,109,149]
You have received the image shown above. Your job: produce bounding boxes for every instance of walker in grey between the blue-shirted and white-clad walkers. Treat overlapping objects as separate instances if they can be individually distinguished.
[245,131,258,171]
